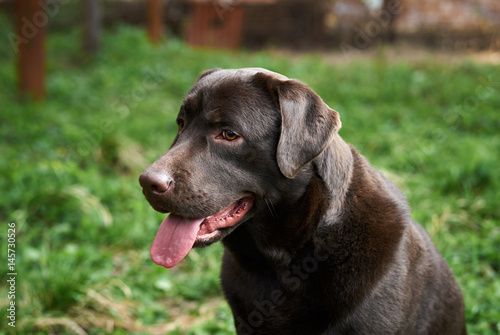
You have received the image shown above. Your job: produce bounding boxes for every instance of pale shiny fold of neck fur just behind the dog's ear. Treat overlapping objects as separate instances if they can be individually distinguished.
[313,134,354,226]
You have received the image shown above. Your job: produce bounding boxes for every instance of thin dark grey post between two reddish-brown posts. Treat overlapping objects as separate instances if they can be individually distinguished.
[82,0,101,55]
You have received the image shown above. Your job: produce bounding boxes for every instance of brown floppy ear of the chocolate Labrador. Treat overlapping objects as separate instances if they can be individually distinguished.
[254,72,341,178]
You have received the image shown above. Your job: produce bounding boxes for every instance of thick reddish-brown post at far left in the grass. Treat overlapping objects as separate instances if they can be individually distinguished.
[16,0,49,101]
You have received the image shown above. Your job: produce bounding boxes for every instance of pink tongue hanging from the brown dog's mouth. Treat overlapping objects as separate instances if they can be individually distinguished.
[149,214,204,268]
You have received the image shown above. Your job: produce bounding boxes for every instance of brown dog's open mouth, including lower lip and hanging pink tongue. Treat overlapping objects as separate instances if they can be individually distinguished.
[150,197,253,268]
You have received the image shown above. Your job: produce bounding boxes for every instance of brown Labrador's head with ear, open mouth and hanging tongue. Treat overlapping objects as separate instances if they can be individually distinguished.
[139,68,340,267]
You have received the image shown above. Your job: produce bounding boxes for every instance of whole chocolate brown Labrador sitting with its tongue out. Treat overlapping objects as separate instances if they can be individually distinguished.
[140,68,466,335]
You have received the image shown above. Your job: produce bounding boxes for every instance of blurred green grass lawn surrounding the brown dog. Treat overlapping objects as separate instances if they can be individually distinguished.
[0,14,500,334]
